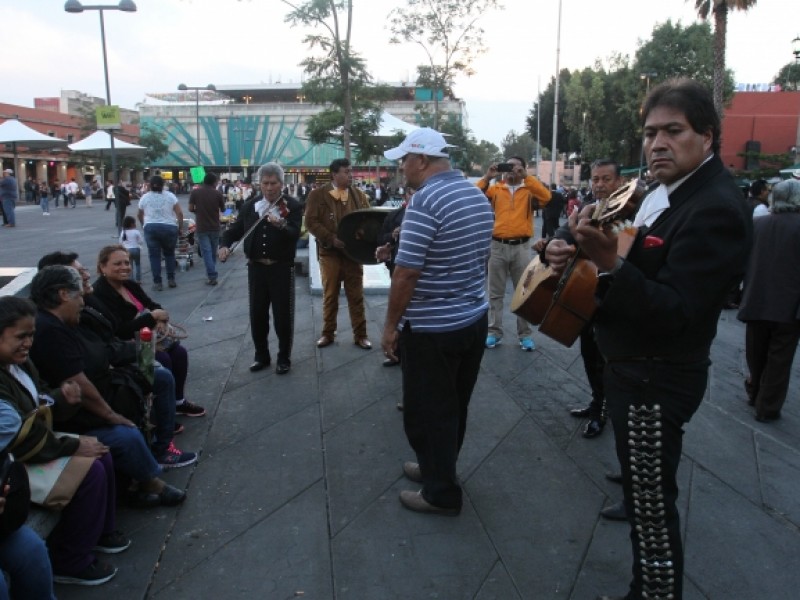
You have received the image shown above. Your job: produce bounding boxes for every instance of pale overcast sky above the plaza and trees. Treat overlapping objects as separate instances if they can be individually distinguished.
[0,0,800,146]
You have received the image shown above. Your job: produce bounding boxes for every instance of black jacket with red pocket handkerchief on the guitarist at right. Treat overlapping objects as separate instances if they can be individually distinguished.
[595,156,753,362]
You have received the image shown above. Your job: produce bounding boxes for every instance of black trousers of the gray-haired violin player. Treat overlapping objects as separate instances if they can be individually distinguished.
[247,261,294,364]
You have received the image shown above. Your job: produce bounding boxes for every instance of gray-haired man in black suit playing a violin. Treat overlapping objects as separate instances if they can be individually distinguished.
[218,162,303,375]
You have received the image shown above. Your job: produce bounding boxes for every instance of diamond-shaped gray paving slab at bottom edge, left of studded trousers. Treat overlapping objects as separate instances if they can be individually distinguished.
[466,419,603,599]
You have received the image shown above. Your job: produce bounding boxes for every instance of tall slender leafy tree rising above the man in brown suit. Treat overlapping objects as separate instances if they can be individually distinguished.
[281,0,386,159]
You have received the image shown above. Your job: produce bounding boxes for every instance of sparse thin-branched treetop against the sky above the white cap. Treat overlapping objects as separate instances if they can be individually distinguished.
[389,0,498,130]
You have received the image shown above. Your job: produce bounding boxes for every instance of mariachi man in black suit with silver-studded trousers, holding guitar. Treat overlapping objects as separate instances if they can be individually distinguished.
[551,79,752,600]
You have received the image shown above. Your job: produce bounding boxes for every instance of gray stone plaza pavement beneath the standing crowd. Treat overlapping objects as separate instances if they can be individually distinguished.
[0,196,800,600]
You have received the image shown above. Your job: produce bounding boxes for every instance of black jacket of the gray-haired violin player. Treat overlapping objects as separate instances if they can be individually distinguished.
[220,194,303,263]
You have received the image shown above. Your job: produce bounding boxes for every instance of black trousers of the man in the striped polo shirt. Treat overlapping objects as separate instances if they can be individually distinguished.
[399,314,489,508]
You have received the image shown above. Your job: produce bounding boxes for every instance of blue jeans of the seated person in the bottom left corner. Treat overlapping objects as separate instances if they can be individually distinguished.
[0,525,55,600]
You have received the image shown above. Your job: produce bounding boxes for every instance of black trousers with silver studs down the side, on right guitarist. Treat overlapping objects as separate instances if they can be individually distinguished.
[605,359,710,600]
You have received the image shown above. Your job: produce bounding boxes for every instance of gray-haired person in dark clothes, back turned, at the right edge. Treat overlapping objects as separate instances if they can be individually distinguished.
[738,179,800,422]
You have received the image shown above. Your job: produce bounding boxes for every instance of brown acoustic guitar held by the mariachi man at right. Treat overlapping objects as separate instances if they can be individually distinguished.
[511,179,645,347]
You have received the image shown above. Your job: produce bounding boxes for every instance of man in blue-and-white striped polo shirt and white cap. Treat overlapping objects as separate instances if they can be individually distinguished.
[381,128,494,515]
